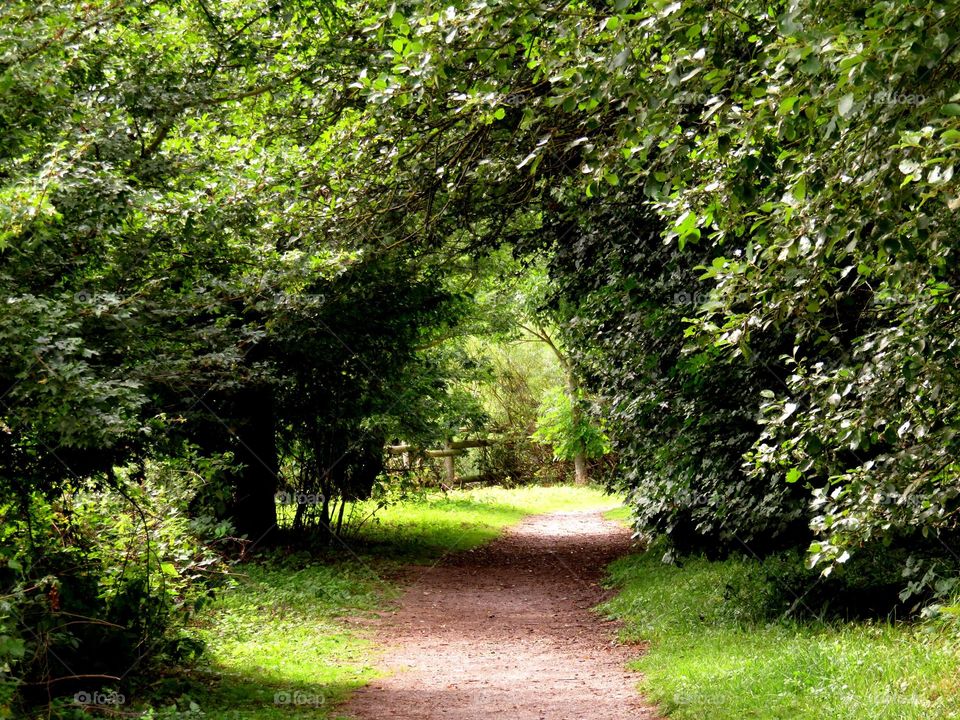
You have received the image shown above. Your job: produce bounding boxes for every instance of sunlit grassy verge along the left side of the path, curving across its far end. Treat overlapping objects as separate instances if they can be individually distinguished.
[172,486,612,720]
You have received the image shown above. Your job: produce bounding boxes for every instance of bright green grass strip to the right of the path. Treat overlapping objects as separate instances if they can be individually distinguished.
[602,552,960,720]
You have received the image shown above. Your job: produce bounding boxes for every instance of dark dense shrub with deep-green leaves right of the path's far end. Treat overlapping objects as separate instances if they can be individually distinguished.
[552,196,807,553]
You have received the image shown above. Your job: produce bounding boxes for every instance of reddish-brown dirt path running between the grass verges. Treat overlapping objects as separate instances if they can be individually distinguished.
[341,512,656,720]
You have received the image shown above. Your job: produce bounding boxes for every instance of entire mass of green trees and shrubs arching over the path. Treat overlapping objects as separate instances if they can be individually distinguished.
[0,0,960,716]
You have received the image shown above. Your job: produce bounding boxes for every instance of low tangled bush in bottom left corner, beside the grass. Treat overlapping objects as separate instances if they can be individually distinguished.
[0,461,230,717]
